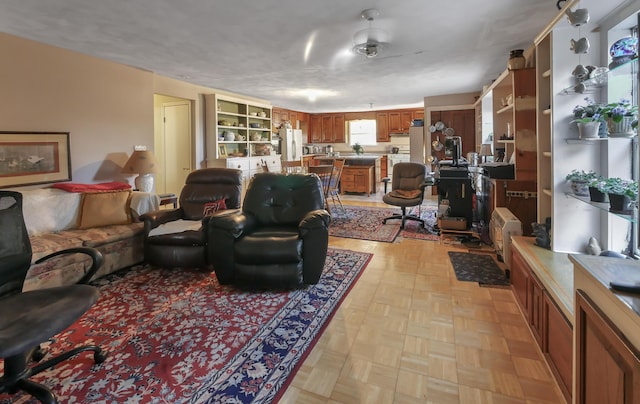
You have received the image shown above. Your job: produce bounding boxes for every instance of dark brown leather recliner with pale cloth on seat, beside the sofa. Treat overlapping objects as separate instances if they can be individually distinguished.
[140,168,242,268]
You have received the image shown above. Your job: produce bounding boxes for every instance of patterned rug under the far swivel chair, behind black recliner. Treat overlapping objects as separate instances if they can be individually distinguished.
[329,205,440,243]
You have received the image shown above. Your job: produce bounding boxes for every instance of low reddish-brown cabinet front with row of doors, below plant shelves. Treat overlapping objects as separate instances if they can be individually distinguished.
[510,246,576,402]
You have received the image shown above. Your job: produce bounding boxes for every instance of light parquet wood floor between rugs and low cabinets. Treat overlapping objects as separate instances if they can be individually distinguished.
[280,192,564,404]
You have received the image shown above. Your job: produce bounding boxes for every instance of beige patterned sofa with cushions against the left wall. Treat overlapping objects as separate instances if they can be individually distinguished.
[20,188,160,290]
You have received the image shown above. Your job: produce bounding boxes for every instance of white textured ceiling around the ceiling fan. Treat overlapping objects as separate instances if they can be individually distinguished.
[0,0,584,112]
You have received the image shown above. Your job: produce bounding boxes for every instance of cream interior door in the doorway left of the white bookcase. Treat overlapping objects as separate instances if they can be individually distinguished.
[155,100,193,195]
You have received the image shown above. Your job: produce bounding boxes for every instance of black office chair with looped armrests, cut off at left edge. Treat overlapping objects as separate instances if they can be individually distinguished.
[0,191,106,403]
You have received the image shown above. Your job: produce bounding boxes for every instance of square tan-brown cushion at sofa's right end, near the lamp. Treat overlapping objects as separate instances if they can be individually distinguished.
[78,190,131,229]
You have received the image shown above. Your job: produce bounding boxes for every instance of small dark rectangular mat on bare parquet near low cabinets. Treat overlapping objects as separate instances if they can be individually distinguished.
[449,251,509,285]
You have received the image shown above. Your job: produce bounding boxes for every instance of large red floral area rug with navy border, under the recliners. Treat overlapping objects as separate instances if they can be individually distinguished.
[5,249,372,403]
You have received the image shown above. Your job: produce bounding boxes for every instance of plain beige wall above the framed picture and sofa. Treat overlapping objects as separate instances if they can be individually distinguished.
[0,33,153,182]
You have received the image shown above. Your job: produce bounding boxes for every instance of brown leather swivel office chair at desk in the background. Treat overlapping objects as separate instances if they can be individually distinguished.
[382,163,427,229]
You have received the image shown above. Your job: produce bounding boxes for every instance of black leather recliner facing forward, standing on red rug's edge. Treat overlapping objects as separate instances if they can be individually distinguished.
[207,173,331,289]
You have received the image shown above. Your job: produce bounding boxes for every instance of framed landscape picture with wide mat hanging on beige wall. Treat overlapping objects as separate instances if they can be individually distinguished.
[0,131,71,188]
